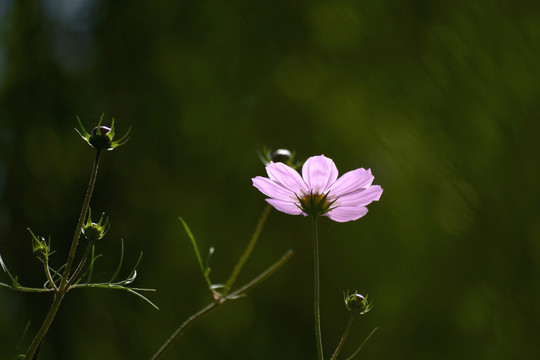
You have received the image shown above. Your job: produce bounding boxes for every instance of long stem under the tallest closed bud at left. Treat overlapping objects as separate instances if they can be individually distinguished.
[25,150,100,360]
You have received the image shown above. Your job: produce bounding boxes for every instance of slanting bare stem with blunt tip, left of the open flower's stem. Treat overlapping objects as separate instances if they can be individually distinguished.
[151,250,293,360]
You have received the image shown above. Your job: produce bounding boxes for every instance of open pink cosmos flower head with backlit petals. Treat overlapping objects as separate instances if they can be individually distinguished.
[252,155,383,222]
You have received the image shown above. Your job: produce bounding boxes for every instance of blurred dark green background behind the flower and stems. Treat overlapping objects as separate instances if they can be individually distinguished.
[0,0,540,360]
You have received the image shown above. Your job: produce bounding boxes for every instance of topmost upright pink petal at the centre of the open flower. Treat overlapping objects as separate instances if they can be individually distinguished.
[302,155,338,193]
